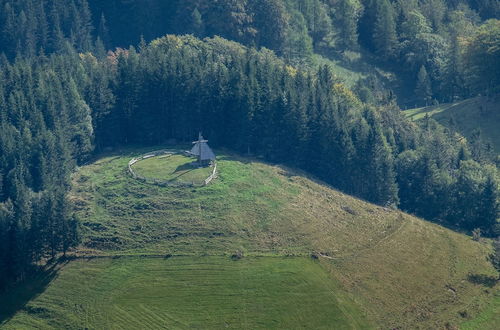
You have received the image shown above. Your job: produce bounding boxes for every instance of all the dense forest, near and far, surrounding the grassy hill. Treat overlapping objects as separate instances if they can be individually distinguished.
[0,0,500,287]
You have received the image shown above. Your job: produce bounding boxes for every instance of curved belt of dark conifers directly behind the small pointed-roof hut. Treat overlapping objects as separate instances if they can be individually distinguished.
[88,36,498,234]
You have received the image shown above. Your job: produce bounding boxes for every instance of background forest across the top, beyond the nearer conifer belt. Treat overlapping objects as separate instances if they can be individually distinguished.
[0,0,500,105]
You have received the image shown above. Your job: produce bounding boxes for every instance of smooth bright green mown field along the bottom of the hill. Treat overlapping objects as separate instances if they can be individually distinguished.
[0,257,367,329]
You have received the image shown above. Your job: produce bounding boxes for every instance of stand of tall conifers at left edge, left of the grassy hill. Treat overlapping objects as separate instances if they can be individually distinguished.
[0,56,89,288]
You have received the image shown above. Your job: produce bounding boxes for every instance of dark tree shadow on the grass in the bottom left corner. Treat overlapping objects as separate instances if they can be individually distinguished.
[0,260,65,328]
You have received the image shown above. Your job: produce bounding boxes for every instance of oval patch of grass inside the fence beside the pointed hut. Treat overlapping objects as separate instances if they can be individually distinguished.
[132,154,213,183]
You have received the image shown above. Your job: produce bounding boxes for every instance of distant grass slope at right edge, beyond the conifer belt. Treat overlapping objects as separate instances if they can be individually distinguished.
[404,96,500,153]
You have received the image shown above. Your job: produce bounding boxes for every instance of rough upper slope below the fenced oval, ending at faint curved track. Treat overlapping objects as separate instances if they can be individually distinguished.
[66,153,404,257]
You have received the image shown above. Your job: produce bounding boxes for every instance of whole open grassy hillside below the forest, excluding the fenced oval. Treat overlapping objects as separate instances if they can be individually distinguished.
[0,149,499,329]
